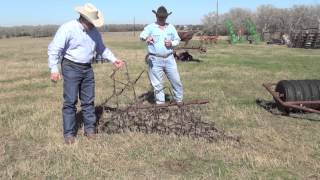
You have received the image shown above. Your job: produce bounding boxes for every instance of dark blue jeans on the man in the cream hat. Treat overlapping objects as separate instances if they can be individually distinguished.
[61,60,96,137]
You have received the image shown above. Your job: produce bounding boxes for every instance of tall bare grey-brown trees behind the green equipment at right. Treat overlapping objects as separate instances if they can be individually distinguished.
[202,5,320,35]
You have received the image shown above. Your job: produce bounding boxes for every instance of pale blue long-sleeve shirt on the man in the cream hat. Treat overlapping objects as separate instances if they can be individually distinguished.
[48,20,116,73]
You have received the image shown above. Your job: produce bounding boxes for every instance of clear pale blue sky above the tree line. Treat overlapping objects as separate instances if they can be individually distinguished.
[0,0,320,26]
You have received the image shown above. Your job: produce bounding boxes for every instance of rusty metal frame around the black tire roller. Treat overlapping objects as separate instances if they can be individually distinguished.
[262,83,320,114]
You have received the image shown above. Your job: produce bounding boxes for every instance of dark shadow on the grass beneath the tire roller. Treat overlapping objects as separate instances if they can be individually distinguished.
[256,99,320,122]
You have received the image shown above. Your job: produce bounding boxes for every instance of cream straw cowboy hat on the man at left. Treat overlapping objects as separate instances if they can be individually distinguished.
[75,3,104,27]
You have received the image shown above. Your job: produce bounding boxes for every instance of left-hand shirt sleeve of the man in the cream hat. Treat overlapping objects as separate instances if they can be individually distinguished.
[48,26,69,73]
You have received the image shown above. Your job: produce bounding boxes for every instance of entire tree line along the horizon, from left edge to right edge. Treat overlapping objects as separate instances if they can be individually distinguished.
[0,5,320,39]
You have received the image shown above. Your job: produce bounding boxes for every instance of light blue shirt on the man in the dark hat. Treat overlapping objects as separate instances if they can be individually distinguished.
[140,23,181,55]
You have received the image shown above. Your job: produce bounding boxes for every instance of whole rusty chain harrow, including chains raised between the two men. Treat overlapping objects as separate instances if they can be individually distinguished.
[98,65,240,142]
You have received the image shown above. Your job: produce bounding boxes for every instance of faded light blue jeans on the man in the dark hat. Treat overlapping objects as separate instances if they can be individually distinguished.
[148,55,183,104]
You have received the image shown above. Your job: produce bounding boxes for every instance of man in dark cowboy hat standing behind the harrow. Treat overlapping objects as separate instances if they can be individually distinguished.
[140,6,183,104]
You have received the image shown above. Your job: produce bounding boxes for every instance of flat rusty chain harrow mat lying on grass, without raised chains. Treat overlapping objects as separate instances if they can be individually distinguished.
[99,105,239,142]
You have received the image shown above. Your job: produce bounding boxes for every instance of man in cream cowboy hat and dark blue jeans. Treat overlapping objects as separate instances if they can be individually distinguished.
[48,3,124,144]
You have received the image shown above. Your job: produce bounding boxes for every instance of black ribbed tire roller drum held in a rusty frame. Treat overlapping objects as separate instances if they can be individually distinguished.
[275,80,320,112]
